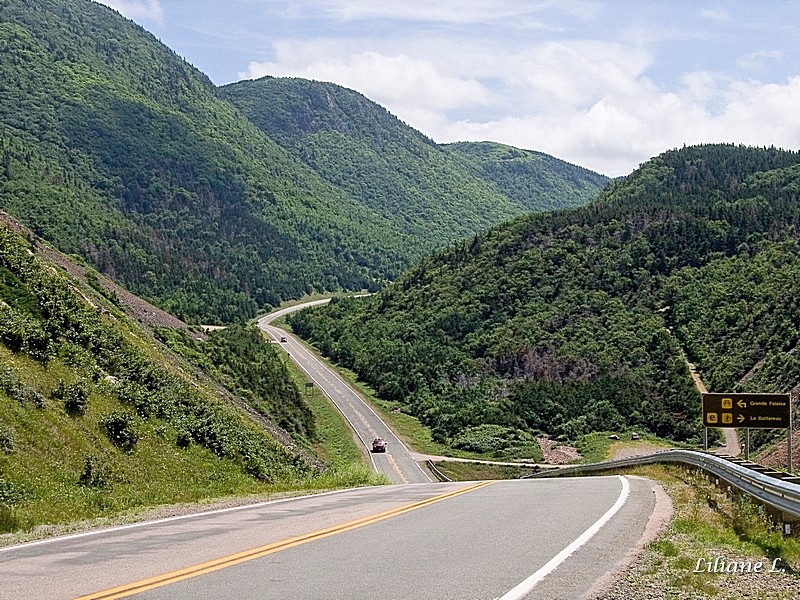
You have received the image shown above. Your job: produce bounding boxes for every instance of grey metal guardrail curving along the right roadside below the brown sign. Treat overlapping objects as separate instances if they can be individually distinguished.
[526,450,800,519]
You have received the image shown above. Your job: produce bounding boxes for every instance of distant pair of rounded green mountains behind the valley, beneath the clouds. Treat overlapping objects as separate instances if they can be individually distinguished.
[220,77,608,260]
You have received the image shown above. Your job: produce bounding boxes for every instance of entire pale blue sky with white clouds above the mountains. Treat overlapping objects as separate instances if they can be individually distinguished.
[95,0,800,176]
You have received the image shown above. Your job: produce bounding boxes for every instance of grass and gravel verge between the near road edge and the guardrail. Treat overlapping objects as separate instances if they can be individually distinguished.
[604,465,800,600]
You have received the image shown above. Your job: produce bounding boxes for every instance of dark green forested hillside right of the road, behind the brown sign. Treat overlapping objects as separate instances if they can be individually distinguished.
[292,145,800,454]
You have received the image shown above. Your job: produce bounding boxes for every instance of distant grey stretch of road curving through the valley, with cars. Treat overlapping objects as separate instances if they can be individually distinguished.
[258,299,431,483]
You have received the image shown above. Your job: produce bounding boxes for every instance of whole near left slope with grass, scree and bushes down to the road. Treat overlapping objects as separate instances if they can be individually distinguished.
[0,213,382,533]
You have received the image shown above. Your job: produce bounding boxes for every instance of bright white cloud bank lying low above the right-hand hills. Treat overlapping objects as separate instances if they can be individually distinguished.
[428,74,800,176]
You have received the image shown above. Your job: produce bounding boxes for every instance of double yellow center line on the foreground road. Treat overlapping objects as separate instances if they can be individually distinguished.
[76,481,494,600]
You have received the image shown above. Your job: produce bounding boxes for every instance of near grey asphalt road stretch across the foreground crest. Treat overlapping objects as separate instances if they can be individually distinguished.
[0,476,655,600]
